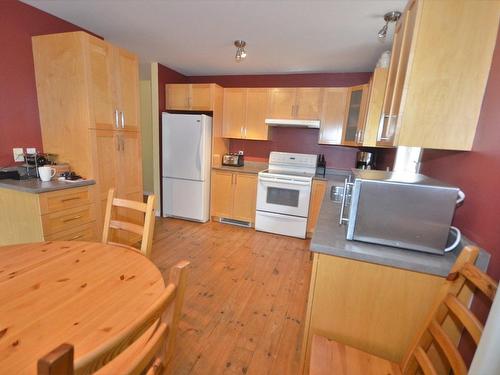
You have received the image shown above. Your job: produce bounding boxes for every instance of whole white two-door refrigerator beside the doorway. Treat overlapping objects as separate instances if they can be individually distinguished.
[162,112,212,222]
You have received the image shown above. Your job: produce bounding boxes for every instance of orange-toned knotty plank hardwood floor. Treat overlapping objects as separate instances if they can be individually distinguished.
[152,219,311,375]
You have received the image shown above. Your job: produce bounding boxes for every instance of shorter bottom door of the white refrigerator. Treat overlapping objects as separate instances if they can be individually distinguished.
[163,178,210,222]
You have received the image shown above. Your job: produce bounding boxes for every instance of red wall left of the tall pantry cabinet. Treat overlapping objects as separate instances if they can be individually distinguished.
[0,0,98,167]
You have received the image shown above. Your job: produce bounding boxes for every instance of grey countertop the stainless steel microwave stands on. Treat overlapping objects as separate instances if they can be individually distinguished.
[310,174,490,276]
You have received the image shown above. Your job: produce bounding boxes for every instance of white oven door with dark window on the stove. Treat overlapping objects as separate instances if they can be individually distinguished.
[257,176,311,217]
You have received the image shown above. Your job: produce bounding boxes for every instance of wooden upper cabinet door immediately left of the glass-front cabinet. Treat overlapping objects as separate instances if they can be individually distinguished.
[318,87,349,145]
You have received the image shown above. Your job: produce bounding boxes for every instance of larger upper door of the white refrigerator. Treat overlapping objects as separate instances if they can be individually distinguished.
[162,113,212,181]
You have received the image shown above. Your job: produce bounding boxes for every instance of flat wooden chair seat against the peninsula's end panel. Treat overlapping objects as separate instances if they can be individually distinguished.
[309,335,401,375]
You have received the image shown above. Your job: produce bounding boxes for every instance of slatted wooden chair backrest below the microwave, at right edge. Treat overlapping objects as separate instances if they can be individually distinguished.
[401,247,498,375]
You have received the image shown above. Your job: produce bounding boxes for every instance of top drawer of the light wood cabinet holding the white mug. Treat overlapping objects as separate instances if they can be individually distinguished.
[40,186,91,215]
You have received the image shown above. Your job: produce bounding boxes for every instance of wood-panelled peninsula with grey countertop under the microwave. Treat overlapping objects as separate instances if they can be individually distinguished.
[302,175,489,374]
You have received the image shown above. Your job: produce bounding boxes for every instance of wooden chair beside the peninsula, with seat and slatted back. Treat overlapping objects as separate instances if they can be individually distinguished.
[309,247,498,375]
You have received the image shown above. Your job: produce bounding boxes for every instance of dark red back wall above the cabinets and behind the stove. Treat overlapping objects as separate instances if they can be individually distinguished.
[188,73,371,169]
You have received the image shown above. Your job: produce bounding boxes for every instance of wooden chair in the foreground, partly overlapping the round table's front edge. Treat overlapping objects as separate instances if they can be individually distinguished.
[38,261,189,375]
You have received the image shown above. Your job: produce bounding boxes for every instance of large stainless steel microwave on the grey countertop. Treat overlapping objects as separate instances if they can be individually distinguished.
[339,169,463,254]
